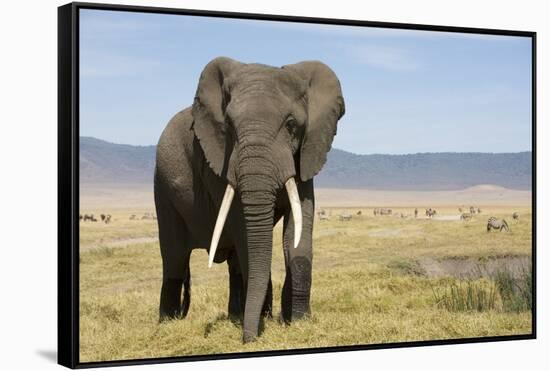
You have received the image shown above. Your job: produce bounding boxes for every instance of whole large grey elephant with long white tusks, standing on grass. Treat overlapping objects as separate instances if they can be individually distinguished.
[154,57,344,343]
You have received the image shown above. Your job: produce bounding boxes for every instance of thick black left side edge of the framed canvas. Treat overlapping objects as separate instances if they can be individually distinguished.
[57,4,79,368]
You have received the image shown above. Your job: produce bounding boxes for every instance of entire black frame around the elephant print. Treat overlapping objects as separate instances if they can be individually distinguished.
[57,2,537,368]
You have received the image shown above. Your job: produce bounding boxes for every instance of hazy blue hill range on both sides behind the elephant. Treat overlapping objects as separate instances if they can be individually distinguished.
[80,137,532,191]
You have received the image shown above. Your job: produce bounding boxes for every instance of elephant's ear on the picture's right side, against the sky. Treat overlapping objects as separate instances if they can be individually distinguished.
[283,61,345,181]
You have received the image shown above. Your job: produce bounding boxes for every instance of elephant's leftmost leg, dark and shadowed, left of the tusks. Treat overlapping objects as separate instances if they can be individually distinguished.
[155,190,191,321]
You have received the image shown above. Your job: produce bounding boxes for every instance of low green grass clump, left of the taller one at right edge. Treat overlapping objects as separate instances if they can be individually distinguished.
[432,280,498,312]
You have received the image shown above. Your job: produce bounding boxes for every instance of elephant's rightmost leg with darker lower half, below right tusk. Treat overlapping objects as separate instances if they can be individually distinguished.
[281,181,315,323]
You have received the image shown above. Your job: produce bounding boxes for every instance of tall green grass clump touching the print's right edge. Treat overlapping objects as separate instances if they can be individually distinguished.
[493,267,533,312]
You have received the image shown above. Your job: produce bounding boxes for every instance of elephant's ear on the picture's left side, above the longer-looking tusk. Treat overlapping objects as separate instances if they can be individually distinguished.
[192,57,242,176]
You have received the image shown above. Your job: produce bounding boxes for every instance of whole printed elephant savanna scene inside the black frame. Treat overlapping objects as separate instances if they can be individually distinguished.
[78,9,533,363]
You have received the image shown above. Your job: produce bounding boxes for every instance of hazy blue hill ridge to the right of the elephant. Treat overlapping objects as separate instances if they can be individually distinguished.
[316,148,532,190]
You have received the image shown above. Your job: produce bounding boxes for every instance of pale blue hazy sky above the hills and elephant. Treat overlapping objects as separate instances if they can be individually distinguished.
[80,10,531,154]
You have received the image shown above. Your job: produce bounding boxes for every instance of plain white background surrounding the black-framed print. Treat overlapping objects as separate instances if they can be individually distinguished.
[0,0,550,371]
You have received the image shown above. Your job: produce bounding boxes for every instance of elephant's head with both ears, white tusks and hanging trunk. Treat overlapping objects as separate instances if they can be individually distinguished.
[192,57,344,339]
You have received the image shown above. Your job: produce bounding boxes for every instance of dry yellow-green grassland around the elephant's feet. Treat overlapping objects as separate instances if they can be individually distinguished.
[80,186,531,362]
